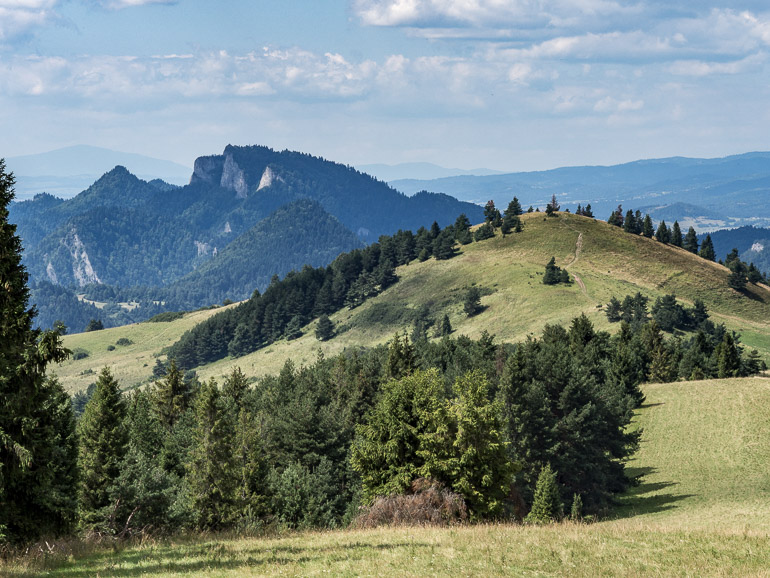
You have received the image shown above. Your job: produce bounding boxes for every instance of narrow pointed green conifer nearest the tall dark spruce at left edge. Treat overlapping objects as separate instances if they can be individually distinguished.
[78,367,128,528]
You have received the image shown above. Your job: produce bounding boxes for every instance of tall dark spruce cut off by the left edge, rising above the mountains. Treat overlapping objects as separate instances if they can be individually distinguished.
[0,159,76,542]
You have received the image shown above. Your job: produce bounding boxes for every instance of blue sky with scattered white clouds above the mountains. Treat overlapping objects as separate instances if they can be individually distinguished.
[0,0,770,171]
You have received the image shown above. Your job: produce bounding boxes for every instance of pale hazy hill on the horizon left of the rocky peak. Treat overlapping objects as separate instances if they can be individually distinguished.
[6,145,192,200]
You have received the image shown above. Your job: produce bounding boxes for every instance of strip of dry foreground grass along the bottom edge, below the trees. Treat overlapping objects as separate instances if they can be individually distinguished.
[6,524,770,578]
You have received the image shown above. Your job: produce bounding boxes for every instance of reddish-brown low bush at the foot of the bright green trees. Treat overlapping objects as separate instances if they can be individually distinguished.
[352,478,468,528]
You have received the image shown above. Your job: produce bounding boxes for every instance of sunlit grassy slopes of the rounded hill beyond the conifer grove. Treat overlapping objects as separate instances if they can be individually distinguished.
[57,213,770,390]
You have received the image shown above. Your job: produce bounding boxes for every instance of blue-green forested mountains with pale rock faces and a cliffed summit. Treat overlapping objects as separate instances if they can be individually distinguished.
[9,146,483,329]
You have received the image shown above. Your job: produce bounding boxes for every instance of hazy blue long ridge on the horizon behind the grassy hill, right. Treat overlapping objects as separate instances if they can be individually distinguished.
[391,152,770,231]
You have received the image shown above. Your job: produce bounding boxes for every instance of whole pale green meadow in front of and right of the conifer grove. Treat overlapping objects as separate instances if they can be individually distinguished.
[7,378,770,576]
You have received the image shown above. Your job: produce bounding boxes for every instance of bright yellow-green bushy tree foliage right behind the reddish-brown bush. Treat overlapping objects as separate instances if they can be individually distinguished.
[351,369,515,518]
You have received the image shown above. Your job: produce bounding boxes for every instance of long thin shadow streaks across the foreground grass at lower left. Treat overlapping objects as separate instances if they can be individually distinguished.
[6,539,430,578]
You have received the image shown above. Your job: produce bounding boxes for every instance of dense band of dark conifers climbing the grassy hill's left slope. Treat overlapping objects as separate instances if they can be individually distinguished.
[168,197,522,369]
